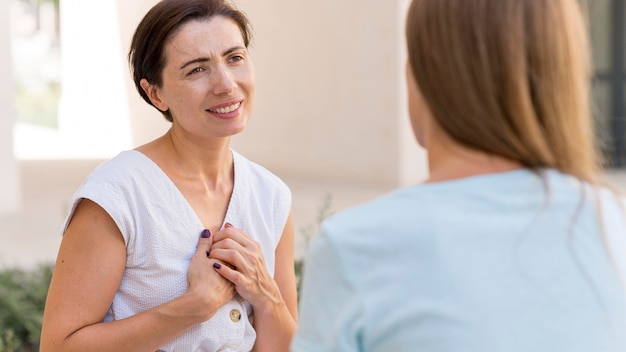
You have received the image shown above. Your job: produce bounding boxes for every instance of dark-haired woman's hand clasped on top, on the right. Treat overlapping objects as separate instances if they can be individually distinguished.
[209,223,282,307]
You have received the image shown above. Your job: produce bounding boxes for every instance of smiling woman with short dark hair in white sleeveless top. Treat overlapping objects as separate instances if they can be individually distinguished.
[41,0,297,352]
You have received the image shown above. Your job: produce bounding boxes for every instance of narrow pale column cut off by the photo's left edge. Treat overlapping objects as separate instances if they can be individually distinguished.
[0,1,21,214]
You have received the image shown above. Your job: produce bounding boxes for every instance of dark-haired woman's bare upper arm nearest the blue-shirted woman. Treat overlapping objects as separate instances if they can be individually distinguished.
[274,213,298,320]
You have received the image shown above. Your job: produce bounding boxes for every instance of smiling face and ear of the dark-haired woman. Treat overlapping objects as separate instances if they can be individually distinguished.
[144,16,254,137]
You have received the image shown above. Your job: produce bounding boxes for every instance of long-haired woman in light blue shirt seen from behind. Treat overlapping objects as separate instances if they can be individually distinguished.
[291,0,626,352]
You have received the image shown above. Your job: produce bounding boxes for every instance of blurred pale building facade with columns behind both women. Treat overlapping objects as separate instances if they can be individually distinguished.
[0,0,626,212]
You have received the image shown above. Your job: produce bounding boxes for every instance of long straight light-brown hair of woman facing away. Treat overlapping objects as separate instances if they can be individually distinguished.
[406,0,599,181]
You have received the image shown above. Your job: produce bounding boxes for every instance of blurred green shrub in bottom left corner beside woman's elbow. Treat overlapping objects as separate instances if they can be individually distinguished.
[0,264,53,352]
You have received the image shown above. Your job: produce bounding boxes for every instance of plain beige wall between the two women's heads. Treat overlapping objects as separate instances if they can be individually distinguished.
[234,0,426,186]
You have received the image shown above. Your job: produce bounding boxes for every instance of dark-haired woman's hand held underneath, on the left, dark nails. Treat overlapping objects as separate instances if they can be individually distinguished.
[187,230,236,319]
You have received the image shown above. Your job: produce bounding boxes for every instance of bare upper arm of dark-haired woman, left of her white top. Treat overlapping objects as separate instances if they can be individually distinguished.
[42,199,126,345]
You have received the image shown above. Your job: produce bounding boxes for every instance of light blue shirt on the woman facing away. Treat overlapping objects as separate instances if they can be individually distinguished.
[292,170,626,352]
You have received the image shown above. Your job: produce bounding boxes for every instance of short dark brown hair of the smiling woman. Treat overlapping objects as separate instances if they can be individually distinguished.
[128,0,252,122]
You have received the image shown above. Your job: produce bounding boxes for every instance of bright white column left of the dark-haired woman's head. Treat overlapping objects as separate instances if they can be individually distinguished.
[59,0,131,158]
